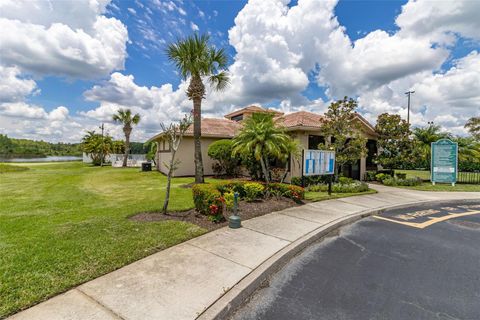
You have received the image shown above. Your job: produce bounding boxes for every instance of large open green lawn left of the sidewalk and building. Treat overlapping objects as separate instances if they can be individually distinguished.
[0,162,210,318]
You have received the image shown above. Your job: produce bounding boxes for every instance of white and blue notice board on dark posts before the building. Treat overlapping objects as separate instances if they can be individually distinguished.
[303,150,335,176]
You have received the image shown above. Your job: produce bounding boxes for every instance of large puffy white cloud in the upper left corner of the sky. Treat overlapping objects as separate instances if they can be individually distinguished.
[0,0,128,78]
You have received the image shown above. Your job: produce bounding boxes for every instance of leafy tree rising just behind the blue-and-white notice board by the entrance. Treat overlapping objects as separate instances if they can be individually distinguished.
[319,97,367,177]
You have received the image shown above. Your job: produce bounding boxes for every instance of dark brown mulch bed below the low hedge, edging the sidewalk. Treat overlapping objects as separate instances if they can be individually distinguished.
[129,198,301,231]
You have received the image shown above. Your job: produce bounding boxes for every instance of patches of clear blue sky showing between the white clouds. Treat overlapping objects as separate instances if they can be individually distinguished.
[31,0,404,111]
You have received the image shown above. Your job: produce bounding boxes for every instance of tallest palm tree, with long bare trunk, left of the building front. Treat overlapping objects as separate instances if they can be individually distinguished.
[167,34,229,183]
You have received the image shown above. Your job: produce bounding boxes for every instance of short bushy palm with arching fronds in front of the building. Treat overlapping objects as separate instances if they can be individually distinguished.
[233,113,296,183]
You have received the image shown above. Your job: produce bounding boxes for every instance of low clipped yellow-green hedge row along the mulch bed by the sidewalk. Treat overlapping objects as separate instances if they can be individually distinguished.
[192,180,305,221]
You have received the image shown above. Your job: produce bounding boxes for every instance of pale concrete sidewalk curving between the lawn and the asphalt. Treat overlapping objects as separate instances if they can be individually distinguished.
[10,185,480,320]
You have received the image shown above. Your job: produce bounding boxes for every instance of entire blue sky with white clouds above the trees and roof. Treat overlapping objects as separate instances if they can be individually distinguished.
[0,0,480,142]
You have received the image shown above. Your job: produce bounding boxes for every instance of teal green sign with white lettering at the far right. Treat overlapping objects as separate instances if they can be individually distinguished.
[430,139,458,186]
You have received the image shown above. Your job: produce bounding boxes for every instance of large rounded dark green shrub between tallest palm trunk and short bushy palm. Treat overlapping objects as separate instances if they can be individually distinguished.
[208,139,239,176]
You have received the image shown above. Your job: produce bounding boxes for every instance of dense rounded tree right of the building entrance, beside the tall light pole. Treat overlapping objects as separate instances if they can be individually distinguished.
[375,113,413,169]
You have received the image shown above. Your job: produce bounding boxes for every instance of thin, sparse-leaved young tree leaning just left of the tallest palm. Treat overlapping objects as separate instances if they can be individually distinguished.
[160,115,192,214]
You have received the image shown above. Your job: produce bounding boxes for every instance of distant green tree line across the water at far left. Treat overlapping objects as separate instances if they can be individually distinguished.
[0,134,82,158]
